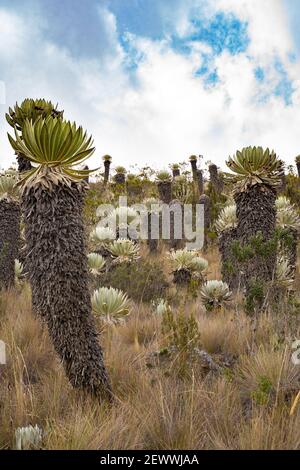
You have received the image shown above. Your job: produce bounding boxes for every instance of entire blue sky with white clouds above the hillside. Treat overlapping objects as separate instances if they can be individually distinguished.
[0,0,300,169]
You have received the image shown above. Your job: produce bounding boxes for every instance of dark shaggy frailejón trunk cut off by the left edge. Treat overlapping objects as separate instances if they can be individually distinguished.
[0,199,21,290]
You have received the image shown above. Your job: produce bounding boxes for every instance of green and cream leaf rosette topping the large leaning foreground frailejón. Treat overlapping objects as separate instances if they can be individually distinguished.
[8,116,95,189]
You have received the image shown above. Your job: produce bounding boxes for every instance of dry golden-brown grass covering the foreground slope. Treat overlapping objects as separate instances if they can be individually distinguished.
[0,249,300,449]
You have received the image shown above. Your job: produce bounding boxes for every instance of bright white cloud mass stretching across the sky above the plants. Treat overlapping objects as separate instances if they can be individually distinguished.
[0,0,300,173]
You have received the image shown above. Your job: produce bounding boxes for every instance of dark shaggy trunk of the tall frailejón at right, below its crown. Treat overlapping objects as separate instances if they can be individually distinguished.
[235,185,276,302]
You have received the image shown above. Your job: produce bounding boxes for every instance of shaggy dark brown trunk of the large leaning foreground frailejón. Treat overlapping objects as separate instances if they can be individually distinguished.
[22,184,112,399]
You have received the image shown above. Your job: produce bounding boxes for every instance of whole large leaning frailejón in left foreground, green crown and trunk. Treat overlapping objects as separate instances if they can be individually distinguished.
[9,113,112,399]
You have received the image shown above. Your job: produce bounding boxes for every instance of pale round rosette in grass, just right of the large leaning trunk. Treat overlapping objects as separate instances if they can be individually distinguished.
[92,287,131,325]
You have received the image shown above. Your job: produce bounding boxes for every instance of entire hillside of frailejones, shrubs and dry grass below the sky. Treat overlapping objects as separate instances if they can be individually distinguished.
[0,100,300,450]
